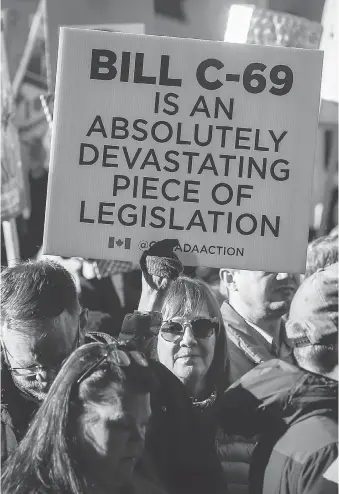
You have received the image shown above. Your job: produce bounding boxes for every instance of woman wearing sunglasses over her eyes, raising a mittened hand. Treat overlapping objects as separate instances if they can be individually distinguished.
[121,240,254,494]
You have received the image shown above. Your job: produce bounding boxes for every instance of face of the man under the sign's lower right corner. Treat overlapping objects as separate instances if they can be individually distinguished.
[233,270,300,318]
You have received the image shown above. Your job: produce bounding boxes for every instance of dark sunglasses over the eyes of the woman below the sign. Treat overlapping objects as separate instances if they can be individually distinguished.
[160,317,219,343]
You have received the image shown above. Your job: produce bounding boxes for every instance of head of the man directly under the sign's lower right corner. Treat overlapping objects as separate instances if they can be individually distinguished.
[219,268,300,324]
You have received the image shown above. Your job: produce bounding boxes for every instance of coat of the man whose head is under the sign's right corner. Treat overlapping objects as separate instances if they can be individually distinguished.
[221,302,294,383]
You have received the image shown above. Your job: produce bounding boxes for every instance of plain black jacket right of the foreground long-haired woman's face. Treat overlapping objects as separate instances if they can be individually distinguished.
[145,360,226,494]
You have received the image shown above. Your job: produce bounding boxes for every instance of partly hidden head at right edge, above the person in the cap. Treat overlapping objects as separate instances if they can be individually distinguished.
[305,236,338,279]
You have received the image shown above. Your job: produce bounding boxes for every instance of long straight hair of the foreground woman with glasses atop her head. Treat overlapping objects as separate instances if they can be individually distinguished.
[2,343,156,494]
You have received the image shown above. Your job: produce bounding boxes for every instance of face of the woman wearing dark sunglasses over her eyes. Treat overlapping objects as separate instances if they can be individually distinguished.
[157,304,216,392]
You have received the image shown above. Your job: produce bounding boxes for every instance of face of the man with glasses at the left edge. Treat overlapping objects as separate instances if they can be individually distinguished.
[2,311,79,401]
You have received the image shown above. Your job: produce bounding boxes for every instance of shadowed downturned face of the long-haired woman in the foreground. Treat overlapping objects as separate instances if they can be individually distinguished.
[79,384,151,485]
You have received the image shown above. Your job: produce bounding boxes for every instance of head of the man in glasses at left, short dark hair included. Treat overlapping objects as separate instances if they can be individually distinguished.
[1,260,87,400]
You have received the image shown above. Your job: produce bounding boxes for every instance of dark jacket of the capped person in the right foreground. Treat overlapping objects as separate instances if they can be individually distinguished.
[221,359,338,494]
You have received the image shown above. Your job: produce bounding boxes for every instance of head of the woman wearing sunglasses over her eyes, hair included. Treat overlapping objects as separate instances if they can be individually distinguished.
[157,276,226,393]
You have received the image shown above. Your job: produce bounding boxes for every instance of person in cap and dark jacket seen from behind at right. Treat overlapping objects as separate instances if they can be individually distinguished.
[221,263,338,494]
